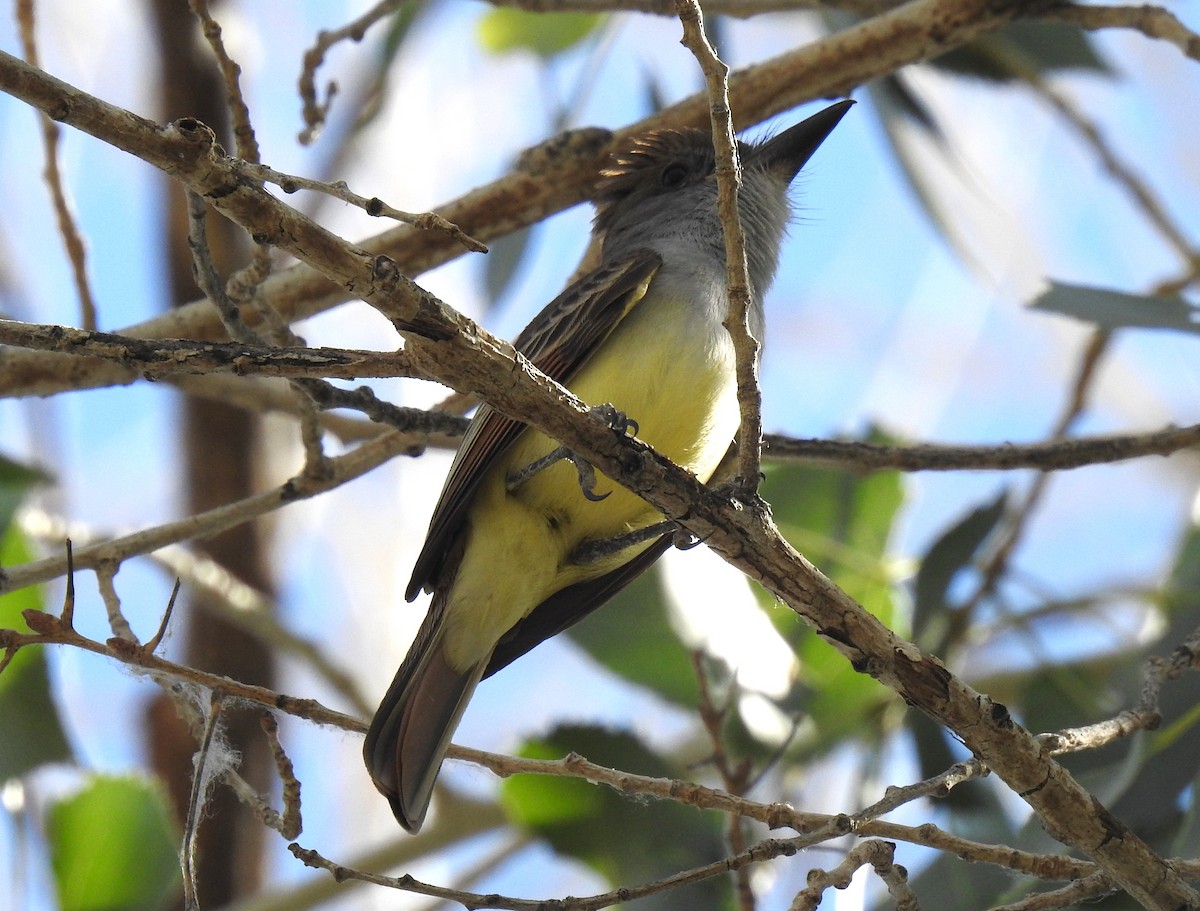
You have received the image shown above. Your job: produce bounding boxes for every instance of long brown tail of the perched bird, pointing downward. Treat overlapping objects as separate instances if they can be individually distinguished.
[362,598,487,832]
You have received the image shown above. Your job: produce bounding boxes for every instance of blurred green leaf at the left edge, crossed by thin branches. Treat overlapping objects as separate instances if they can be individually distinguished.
[0,487,71,781]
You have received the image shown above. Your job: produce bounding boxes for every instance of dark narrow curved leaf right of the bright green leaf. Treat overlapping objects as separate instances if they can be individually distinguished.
[912,492,1008,654]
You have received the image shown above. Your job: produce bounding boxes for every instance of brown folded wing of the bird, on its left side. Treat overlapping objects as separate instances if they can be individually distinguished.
[404,251,662,602]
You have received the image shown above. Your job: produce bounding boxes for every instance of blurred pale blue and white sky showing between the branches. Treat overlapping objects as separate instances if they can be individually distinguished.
[0,0,1200,909]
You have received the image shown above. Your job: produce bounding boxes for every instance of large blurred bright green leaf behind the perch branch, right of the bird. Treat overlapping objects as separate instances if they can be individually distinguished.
[755,446,904,753]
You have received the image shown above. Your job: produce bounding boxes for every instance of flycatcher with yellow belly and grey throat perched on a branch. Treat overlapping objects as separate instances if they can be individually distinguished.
[364,101,853,832]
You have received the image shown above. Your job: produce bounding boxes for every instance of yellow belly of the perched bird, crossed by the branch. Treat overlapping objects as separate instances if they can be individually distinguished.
[445,288,738,669]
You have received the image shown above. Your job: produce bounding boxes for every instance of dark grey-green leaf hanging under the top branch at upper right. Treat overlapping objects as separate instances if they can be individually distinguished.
[930,22,1112,82]
